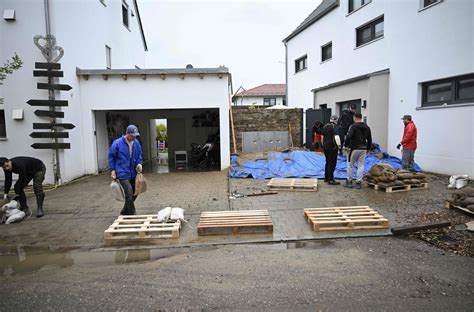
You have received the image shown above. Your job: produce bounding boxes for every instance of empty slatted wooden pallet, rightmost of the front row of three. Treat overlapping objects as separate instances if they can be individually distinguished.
[304,206,388,231]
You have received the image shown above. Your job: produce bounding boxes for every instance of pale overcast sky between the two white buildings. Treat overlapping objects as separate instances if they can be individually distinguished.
[138,0,321,91]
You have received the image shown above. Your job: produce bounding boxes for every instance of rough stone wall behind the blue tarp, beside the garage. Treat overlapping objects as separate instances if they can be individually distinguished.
[230,106,303,152]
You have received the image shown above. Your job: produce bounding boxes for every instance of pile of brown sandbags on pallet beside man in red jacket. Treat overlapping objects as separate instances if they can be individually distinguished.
[365,164,428,187]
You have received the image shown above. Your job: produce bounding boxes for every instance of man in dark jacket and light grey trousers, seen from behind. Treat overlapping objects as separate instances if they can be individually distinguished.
[345,113,372,189]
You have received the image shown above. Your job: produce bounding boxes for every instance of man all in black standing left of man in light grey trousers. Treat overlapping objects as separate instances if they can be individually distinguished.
[322,115,340,185]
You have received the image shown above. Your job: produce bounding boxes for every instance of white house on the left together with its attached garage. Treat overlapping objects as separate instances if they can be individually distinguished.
[0,0,231,182]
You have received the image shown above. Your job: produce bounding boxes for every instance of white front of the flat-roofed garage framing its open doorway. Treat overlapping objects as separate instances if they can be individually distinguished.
[80,75,230,172]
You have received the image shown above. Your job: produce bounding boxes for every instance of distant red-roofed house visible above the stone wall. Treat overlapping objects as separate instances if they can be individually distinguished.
[232,83,286,106]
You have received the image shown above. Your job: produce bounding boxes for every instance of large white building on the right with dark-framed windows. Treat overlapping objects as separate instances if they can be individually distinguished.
[284,0,474,176]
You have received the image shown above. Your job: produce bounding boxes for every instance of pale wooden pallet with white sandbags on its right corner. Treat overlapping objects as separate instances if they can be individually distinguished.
[104,215,181,241]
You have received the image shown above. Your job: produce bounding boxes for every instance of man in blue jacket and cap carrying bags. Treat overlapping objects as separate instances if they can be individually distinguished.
[109,125,143,215]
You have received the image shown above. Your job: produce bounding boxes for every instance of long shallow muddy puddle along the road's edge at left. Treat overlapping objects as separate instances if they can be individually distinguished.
[0,247,186,276]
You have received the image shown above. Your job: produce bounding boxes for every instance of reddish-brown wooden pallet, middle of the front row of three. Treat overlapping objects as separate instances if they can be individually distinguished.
[197,210,273,235]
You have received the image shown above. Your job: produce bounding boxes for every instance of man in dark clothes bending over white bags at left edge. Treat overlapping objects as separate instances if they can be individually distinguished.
[0,157,46,218]
